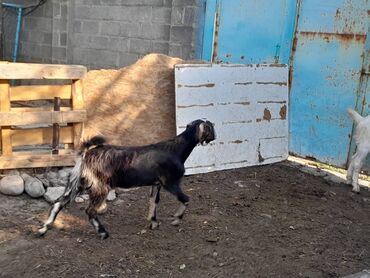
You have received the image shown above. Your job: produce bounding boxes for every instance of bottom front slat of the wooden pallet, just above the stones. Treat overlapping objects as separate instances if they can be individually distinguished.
[0,152,77,169]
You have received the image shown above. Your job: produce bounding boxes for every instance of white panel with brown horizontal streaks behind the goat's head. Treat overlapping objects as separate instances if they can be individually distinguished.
[175,64,288,174]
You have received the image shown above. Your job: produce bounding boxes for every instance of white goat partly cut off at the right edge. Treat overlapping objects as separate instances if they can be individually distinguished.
[347,108,370,192]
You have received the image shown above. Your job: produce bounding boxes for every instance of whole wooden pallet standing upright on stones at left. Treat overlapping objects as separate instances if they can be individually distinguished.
[0,62,87,169]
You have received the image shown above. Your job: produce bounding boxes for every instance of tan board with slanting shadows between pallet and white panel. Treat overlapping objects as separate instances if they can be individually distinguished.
[83,54,188,145]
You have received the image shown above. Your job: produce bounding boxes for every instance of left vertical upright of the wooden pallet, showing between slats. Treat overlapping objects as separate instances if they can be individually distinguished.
[0,80,12,155]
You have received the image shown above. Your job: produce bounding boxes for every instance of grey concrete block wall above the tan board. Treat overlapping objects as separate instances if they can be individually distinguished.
[5,0,205,69]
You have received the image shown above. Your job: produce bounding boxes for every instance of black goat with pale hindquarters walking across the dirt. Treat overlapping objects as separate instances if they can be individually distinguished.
[38,120,215,239]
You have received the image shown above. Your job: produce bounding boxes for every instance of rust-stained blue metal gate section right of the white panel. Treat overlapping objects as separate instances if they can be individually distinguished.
[290,0,368,167]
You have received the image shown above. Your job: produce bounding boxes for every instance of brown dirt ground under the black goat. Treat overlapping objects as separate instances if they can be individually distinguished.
[0,162,370,278]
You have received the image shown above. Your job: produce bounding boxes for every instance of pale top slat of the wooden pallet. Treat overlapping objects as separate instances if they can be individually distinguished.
[0,62,87,79]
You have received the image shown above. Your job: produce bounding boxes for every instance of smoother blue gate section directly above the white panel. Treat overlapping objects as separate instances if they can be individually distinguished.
[202,0,296,64]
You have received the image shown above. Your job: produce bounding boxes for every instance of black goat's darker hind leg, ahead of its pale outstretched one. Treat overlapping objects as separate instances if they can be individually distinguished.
[86,186,109,239]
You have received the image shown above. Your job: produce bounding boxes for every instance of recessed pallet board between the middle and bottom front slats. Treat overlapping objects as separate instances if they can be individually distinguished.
[11,126,73,147]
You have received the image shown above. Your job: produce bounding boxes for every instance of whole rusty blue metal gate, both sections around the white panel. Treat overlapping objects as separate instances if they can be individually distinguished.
[202,0,370,167]
